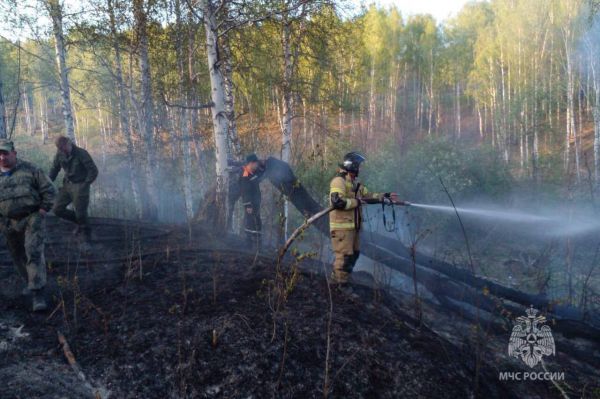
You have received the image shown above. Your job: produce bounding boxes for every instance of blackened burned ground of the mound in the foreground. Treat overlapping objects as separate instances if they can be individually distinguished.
[0,219,598,398]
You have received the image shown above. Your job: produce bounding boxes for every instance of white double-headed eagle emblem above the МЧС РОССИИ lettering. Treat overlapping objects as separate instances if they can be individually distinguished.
[508,306,556,368]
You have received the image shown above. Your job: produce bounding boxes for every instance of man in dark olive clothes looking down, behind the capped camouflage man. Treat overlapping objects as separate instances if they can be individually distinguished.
[49,136,98,243]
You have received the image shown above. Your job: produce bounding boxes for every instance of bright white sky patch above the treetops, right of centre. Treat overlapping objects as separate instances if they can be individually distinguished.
[352,0,469,22]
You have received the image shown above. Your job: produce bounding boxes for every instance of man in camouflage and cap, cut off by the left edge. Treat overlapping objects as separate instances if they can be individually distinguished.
[0,139,55,312]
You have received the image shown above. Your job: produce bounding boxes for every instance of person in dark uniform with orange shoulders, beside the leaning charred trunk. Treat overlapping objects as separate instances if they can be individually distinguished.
[240,154,262,249]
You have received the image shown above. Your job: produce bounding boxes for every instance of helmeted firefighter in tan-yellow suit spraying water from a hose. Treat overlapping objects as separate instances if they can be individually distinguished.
[329,152,397,288]
